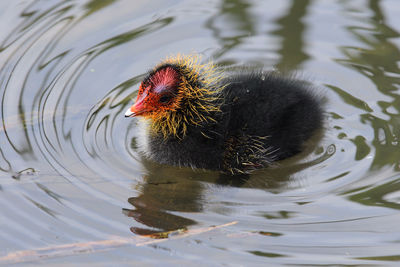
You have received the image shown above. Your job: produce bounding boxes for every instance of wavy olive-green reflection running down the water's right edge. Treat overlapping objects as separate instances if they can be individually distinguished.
[335,0,400,209]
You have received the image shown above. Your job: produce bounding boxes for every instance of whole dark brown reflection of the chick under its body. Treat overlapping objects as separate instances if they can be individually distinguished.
[124,141,335,235]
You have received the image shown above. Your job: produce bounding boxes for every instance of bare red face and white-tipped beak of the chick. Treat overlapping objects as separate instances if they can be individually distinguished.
[125,67,180,117]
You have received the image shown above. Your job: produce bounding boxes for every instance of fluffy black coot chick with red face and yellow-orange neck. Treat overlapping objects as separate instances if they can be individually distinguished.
[125,55,323,175]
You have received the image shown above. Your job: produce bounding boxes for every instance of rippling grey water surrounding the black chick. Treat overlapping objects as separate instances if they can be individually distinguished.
[0,0,400,266]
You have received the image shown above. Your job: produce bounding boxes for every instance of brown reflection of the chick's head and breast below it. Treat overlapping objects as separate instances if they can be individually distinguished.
[125,161,203,235]
